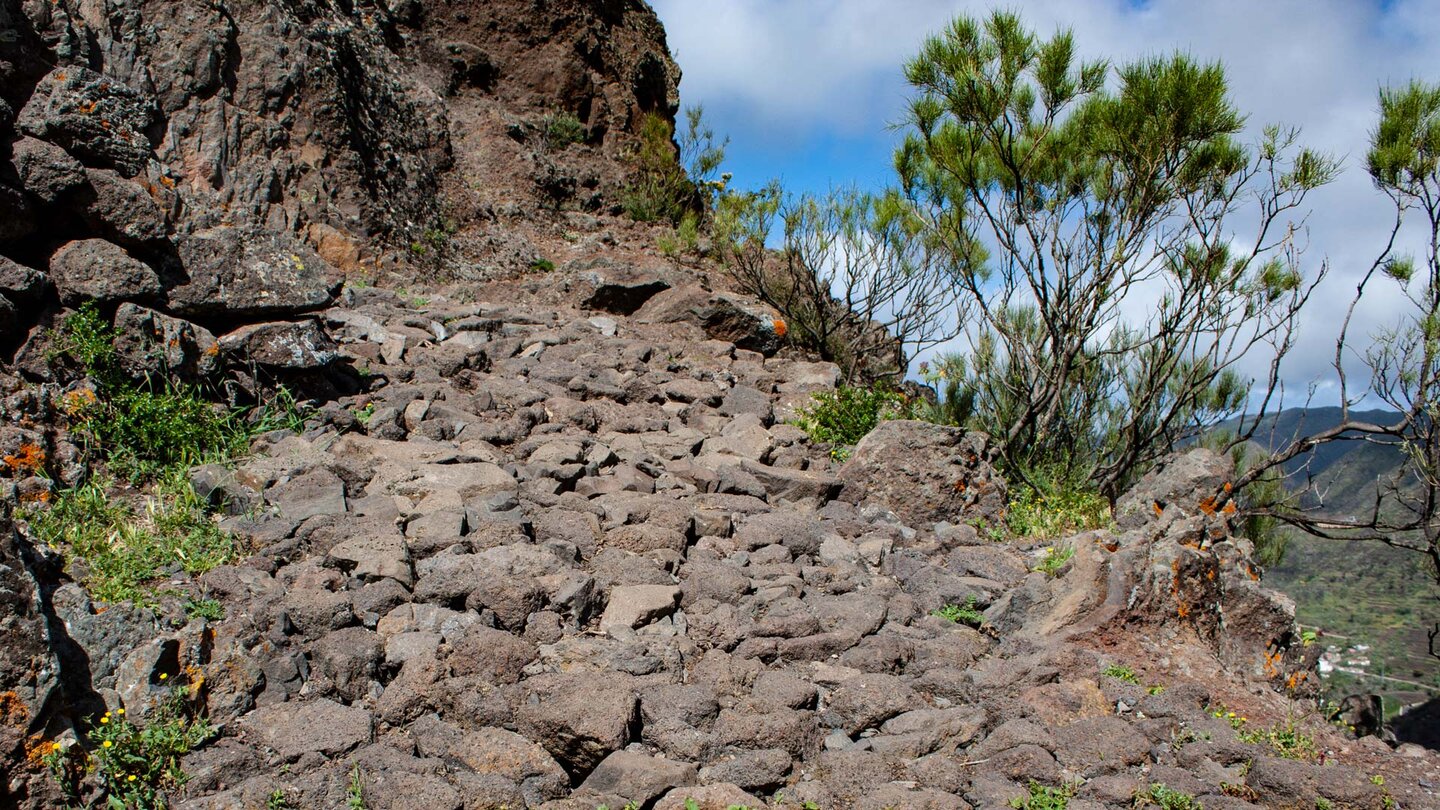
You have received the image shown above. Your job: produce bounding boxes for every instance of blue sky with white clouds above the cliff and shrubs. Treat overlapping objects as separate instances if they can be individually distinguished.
[651,0,1440,399]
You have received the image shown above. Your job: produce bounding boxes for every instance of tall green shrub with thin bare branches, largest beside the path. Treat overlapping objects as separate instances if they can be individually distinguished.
[896,12,1335,502]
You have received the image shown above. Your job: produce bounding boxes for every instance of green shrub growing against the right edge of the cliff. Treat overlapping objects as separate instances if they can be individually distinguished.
[621,107,730,225]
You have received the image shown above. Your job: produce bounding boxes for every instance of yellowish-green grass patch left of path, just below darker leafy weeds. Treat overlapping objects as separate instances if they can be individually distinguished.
[27,470,238,605]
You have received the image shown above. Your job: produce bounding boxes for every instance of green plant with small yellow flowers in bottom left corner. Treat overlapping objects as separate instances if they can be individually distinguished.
[42,687,216,810]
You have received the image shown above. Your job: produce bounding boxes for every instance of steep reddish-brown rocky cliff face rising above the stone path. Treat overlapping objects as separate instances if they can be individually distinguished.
[0,0,680,343]
